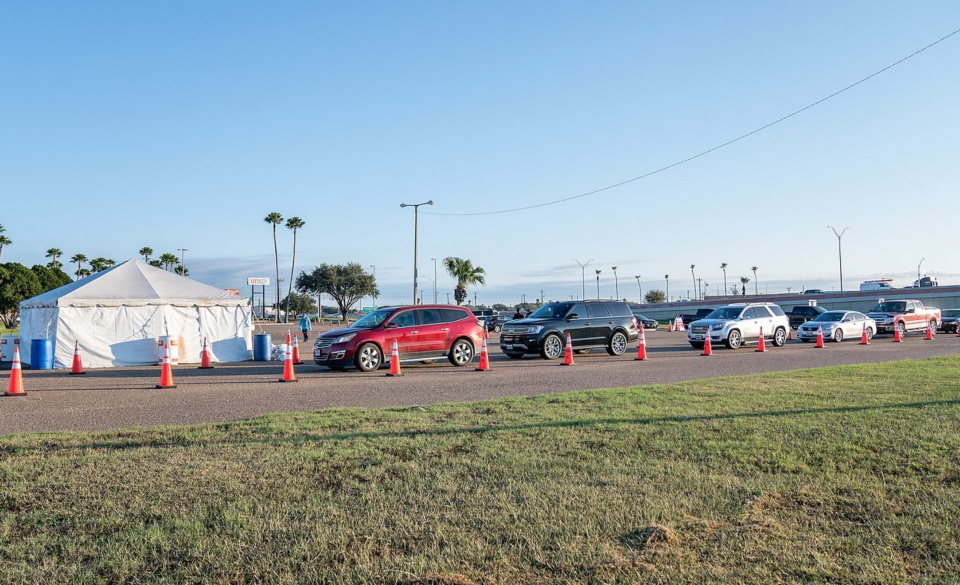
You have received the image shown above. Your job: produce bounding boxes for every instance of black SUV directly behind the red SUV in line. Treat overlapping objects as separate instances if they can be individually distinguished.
[500,301,639,360]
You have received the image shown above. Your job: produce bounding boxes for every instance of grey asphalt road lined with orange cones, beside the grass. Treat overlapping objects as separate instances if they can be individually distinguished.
[0,327,960,435]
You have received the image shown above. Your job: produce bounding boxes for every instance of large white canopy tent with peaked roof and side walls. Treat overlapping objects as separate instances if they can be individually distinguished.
[20,259,252,368]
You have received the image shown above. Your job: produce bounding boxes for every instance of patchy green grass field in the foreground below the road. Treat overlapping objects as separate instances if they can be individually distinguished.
[0,358,960,584]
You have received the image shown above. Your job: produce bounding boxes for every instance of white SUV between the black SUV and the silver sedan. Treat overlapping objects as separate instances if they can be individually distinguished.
[687,303,790,349]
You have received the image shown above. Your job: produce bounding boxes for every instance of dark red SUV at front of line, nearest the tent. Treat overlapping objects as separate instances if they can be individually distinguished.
[313,305,486,372]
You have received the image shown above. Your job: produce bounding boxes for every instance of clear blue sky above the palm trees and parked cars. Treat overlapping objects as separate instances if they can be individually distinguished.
[0,0,960,303]
